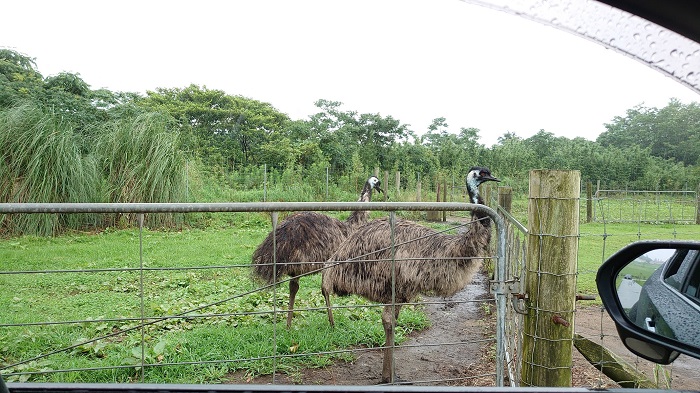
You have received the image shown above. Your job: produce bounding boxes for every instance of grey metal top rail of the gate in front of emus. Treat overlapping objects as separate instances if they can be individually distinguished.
[0,202,495,216]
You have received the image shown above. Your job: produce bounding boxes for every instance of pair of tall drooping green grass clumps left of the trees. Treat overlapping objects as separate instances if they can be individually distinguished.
[0,105,187,235]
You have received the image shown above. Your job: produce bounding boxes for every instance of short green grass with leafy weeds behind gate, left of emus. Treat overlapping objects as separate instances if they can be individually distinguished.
[0,220,428,383]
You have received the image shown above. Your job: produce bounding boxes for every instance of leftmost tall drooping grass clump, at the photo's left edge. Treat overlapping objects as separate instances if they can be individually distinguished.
[0,105,101,234]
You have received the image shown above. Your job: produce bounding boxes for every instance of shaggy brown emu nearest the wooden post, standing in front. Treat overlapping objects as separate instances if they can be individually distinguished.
[321,167,500,383]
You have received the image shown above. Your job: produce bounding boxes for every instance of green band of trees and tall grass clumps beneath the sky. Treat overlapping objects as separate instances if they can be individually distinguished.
[0,49,700,231]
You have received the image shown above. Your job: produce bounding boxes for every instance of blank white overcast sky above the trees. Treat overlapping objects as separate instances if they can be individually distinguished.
[0,0,700,145]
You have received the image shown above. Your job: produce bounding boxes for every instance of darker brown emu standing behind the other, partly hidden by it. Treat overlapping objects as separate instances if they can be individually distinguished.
[253,176,383,327]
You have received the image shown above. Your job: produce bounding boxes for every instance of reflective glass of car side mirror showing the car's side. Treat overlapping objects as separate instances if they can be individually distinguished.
[616,249,700,347]
